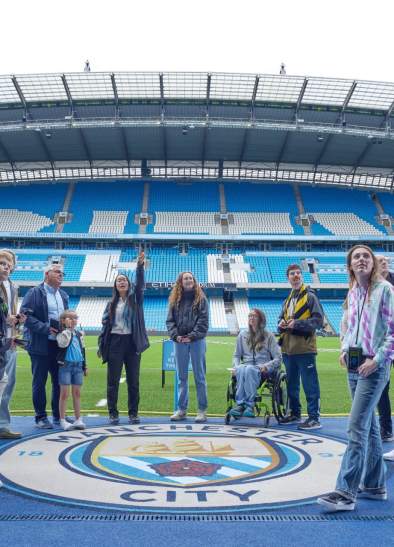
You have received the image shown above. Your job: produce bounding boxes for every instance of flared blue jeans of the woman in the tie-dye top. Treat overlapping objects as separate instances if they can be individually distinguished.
[335,366,390,499]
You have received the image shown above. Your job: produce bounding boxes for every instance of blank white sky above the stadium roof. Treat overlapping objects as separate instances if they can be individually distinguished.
[0,0,394,82]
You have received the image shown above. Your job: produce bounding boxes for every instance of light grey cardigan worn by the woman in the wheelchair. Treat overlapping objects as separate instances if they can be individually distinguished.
[233,329,282,373]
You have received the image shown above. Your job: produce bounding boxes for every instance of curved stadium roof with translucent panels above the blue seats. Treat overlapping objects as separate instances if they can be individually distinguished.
[0,72,394,190]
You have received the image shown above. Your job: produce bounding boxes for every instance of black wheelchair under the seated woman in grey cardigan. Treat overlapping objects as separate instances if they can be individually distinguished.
[224,369,289,427]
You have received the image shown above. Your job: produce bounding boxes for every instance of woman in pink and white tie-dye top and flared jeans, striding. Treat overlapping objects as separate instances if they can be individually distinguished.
[318,245,394,511]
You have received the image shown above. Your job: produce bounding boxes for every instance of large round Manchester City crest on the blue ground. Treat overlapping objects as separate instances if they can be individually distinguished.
[0,424,345,513]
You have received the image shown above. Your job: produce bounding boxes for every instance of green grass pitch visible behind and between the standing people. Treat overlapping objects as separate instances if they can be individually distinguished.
[11,336,394,416]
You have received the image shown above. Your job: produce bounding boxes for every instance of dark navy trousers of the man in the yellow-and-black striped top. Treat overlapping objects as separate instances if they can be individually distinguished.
[283,353,320,420]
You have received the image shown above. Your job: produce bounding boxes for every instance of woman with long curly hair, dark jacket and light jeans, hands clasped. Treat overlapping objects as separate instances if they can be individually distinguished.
[166,272,208,423]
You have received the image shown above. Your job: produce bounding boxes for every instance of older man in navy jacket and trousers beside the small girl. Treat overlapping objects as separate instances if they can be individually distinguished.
[21,264,68,429]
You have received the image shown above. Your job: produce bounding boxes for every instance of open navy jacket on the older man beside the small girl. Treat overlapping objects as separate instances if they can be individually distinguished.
[21,283,68,355]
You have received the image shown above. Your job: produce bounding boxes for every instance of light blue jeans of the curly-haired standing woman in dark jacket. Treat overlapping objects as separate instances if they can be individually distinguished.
[175,338,208,411]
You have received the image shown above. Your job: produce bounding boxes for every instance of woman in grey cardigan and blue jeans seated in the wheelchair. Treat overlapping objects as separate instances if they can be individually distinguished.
[230,308,282,418]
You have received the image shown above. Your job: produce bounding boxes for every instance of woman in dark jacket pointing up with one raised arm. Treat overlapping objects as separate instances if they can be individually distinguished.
[99,253,149,425]
